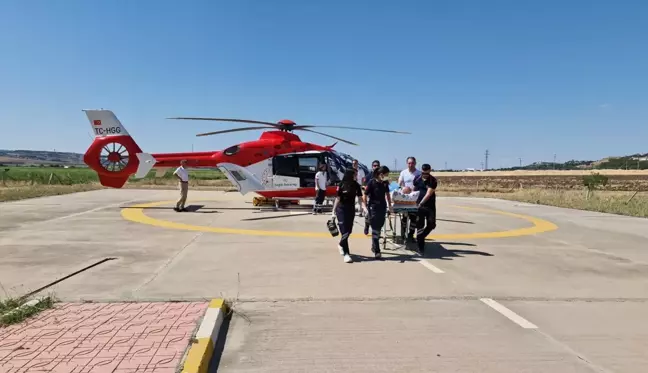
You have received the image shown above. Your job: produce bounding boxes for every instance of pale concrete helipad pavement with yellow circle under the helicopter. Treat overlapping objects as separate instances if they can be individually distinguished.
[0,190,648,372]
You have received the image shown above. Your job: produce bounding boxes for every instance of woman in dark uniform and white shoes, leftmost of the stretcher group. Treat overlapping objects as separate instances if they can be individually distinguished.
[333,169,367,263]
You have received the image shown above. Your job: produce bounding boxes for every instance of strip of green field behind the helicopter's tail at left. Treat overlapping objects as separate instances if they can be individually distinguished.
[0,167,226,185]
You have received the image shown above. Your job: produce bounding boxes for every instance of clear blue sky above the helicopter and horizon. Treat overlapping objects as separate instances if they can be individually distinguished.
[0,0,648,169]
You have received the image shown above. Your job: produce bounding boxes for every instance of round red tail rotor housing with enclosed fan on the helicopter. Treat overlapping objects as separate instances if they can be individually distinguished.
[83,136,142,188]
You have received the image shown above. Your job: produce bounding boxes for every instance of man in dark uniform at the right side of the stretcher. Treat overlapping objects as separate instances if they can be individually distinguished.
[414,163,438,254]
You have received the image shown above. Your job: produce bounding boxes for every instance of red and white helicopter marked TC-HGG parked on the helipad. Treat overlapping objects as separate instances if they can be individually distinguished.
[83,109,408,200]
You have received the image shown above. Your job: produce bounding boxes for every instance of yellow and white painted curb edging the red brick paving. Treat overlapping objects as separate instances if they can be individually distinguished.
[181,299,227,373]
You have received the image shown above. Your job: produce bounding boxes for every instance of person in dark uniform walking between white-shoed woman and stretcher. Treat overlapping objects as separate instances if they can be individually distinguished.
[364,166,391,259]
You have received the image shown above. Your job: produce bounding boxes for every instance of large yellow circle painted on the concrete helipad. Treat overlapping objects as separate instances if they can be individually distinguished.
[121,201,558,240]
